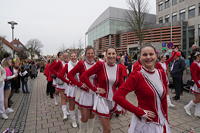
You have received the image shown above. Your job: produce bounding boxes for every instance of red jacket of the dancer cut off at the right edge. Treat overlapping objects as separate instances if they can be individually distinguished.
[190,61,200,88]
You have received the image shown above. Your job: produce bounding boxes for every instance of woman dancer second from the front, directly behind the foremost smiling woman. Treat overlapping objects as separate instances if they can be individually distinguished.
[81,48,124,133]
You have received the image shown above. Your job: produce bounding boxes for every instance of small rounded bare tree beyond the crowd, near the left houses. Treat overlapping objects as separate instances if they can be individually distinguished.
[26,39,43,59]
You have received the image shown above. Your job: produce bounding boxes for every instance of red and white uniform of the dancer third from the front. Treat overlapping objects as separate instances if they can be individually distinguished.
[67,61,95,109]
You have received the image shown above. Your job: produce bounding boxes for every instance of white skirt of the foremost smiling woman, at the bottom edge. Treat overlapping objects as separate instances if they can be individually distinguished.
[128,114,171,133]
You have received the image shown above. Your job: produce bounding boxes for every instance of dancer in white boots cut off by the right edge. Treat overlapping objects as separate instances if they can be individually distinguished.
[184,52,200,117]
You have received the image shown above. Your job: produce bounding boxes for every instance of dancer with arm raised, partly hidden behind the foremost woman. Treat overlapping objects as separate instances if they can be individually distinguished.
[155,49,178,107]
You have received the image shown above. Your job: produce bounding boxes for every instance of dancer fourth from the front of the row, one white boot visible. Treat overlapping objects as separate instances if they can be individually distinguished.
[58,53,78,127]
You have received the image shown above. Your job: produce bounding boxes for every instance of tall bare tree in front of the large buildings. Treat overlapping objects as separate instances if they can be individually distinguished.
[127,0,148,46]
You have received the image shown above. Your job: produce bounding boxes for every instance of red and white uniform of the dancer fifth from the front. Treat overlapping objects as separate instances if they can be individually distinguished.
[49,60,65,90]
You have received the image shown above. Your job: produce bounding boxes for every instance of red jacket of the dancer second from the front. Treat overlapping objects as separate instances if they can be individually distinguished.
[80,61,124,98]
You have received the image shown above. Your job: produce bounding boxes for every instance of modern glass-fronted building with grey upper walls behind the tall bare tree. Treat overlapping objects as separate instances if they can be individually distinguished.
[86,7,156,45]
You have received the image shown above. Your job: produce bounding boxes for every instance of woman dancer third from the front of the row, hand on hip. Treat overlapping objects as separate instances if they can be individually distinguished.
[67,46,95,133]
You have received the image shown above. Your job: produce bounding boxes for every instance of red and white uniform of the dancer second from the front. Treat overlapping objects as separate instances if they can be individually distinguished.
[81,61,124,117]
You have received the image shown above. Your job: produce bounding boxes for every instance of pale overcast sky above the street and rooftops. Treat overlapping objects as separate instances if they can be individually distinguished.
[0,0,156,55]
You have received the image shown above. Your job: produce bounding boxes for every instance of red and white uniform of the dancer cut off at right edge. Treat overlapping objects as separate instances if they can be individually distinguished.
[190,61,200,94]
